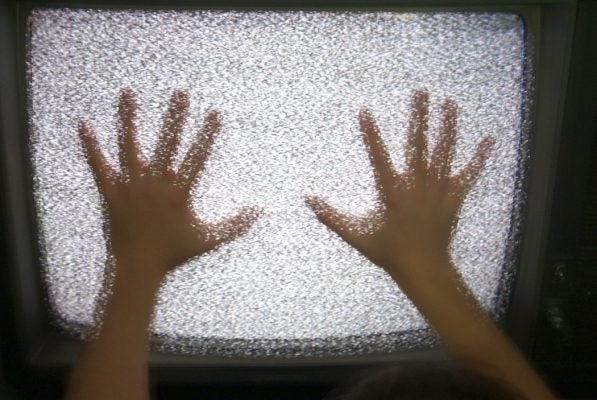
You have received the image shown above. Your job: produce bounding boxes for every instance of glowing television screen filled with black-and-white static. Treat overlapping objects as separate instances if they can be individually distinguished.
[27,9,529,356]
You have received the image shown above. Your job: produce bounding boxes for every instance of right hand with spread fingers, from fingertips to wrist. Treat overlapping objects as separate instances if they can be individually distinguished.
[306,90,495,277]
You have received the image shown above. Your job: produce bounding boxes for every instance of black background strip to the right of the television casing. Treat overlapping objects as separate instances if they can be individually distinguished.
[530,0,597,398]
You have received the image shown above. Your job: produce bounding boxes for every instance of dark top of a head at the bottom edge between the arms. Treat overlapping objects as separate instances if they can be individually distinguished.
[326,362,524,400]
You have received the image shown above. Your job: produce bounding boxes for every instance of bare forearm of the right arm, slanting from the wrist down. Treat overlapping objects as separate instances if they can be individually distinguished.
[394,256,555,400]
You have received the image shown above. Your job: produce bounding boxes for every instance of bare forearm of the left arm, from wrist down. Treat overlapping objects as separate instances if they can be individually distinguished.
[66,263,160,400]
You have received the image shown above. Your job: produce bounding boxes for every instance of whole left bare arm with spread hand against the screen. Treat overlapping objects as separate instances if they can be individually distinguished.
[66,90,255,400]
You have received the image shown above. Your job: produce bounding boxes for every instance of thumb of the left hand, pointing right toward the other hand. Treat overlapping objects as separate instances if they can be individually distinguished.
[205,207,261,251]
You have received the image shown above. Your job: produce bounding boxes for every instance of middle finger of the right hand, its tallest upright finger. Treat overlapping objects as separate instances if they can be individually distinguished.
[406,90,429,179]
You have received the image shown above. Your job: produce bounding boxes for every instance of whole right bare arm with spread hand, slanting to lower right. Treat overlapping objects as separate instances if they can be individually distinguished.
[308,91,555,400]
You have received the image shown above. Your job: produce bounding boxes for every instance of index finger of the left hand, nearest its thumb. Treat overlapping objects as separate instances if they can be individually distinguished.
[179,111,221,188]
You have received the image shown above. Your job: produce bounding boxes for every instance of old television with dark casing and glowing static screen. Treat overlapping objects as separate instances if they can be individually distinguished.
[0,0,588,398]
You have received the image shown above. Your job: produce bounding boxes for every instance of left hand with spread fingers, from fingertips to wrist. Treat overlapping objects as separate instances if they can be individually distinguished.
[78,89,257,276]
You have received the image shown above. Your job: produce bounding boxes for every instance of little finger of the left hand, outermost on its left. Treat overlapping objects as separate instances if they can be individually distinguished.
[77,121,117,193]
